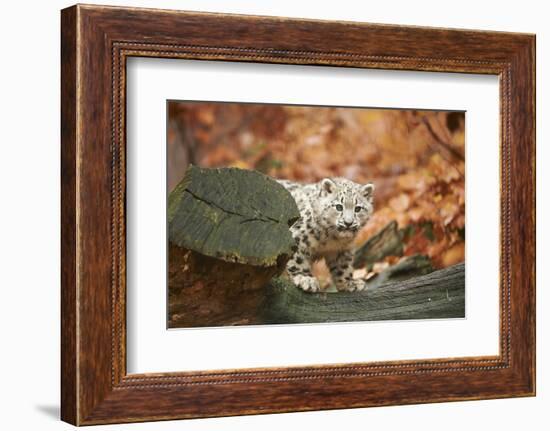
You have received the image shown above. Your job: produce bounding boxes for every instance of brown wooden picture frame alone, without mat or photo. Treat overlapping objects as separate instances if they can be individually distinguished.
[61,5,535,425]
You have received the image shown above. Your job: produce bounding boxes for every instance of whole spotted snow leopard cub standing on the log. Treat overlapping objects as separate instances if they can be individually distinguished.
[279,178,374,292]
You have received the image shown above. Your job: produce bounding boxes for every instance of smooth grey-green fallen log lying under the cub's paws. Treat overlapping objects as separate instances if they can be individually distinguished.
[259,263,465,323]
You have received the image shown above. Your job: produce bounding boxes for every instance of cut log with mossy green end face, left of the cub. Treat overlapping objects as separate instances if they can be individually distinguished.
[168,166,300,328]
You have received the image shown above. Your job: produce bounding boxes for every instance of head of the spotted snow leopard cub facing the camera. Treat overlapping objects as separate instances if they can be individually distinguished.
[315,178,374,239]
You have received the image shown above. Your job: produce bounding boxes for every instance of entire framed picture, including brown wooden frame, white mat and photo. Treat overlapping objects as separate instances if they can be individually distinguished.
[61,5,535,425]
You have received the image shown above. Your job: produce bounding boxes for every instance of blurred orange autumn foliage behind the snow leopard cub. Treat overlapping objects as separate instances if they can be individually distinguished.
[167,101,465,284]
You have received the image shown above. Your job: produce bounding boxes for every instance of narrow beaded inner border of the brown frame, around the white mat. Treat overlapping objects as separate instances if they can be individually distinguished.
[111,41,511,389]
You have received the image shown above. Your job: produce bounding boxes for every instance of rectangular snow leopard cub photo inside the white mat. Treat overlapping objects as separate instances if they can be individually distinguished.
[165,101,470,328]
